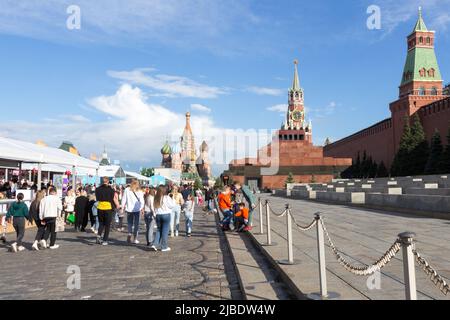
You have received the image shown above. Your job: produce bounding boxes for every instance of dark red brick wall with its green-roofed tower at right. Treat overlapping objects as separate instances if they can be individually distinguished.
[324,10,450,168]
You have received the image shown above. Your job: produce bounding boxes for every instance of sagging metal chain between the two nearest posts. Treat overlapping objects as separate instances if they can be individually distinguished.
[320,218,401,276]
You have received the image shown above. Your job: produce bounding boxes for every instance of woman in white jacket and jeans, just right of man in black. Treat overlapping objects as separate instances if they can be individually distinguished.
[122,180,145,244]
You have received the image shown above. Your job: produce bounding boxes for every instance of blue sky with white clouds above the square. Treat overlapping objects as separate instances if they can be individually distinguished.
[0,0,450,174]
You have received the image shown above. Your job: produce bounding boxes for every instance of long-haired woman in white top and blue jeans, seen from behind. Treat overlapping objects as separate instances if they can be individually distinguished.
[152,186,176,252]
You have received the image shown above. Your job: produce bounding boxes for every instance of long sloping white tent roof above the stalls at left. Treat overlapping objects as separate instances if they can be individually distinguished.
[0,137,99,169]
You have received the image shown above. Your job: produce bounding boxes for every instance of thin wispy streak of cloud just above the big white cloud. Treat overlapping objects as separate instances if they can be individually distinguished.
[108,69,226,99]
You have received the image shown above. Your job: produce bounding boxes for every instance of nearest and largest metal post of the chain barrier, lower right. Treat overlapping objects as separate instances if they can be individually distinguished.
[398,232,417,300]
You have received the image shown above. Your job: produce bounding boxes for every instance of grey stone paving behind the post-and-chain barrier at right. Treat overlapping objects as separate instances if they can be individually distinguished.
[254,195,450,299]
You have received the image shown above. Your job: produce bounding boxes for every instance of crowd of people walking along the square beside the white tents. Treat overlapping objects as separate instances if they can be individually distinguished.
[0,177,256,252]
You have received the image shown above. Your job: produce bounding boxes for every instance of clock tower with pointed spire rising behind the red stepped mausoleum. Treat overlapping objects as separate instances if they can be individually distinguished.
[279,60,312,142]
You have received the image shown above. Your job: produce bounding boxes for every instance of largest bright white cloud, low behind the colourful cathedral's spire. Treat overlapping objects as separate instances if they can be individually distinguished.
[0,84,272,173]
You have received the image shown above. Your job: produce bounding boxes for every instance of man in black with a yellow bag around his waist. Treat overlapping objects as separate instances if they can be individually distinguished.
[95,177,120,246]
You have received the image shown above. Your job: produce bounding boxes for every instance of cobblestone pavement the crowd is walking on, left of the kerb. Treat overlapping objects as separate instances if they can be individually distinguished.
[0,212,240,300]
